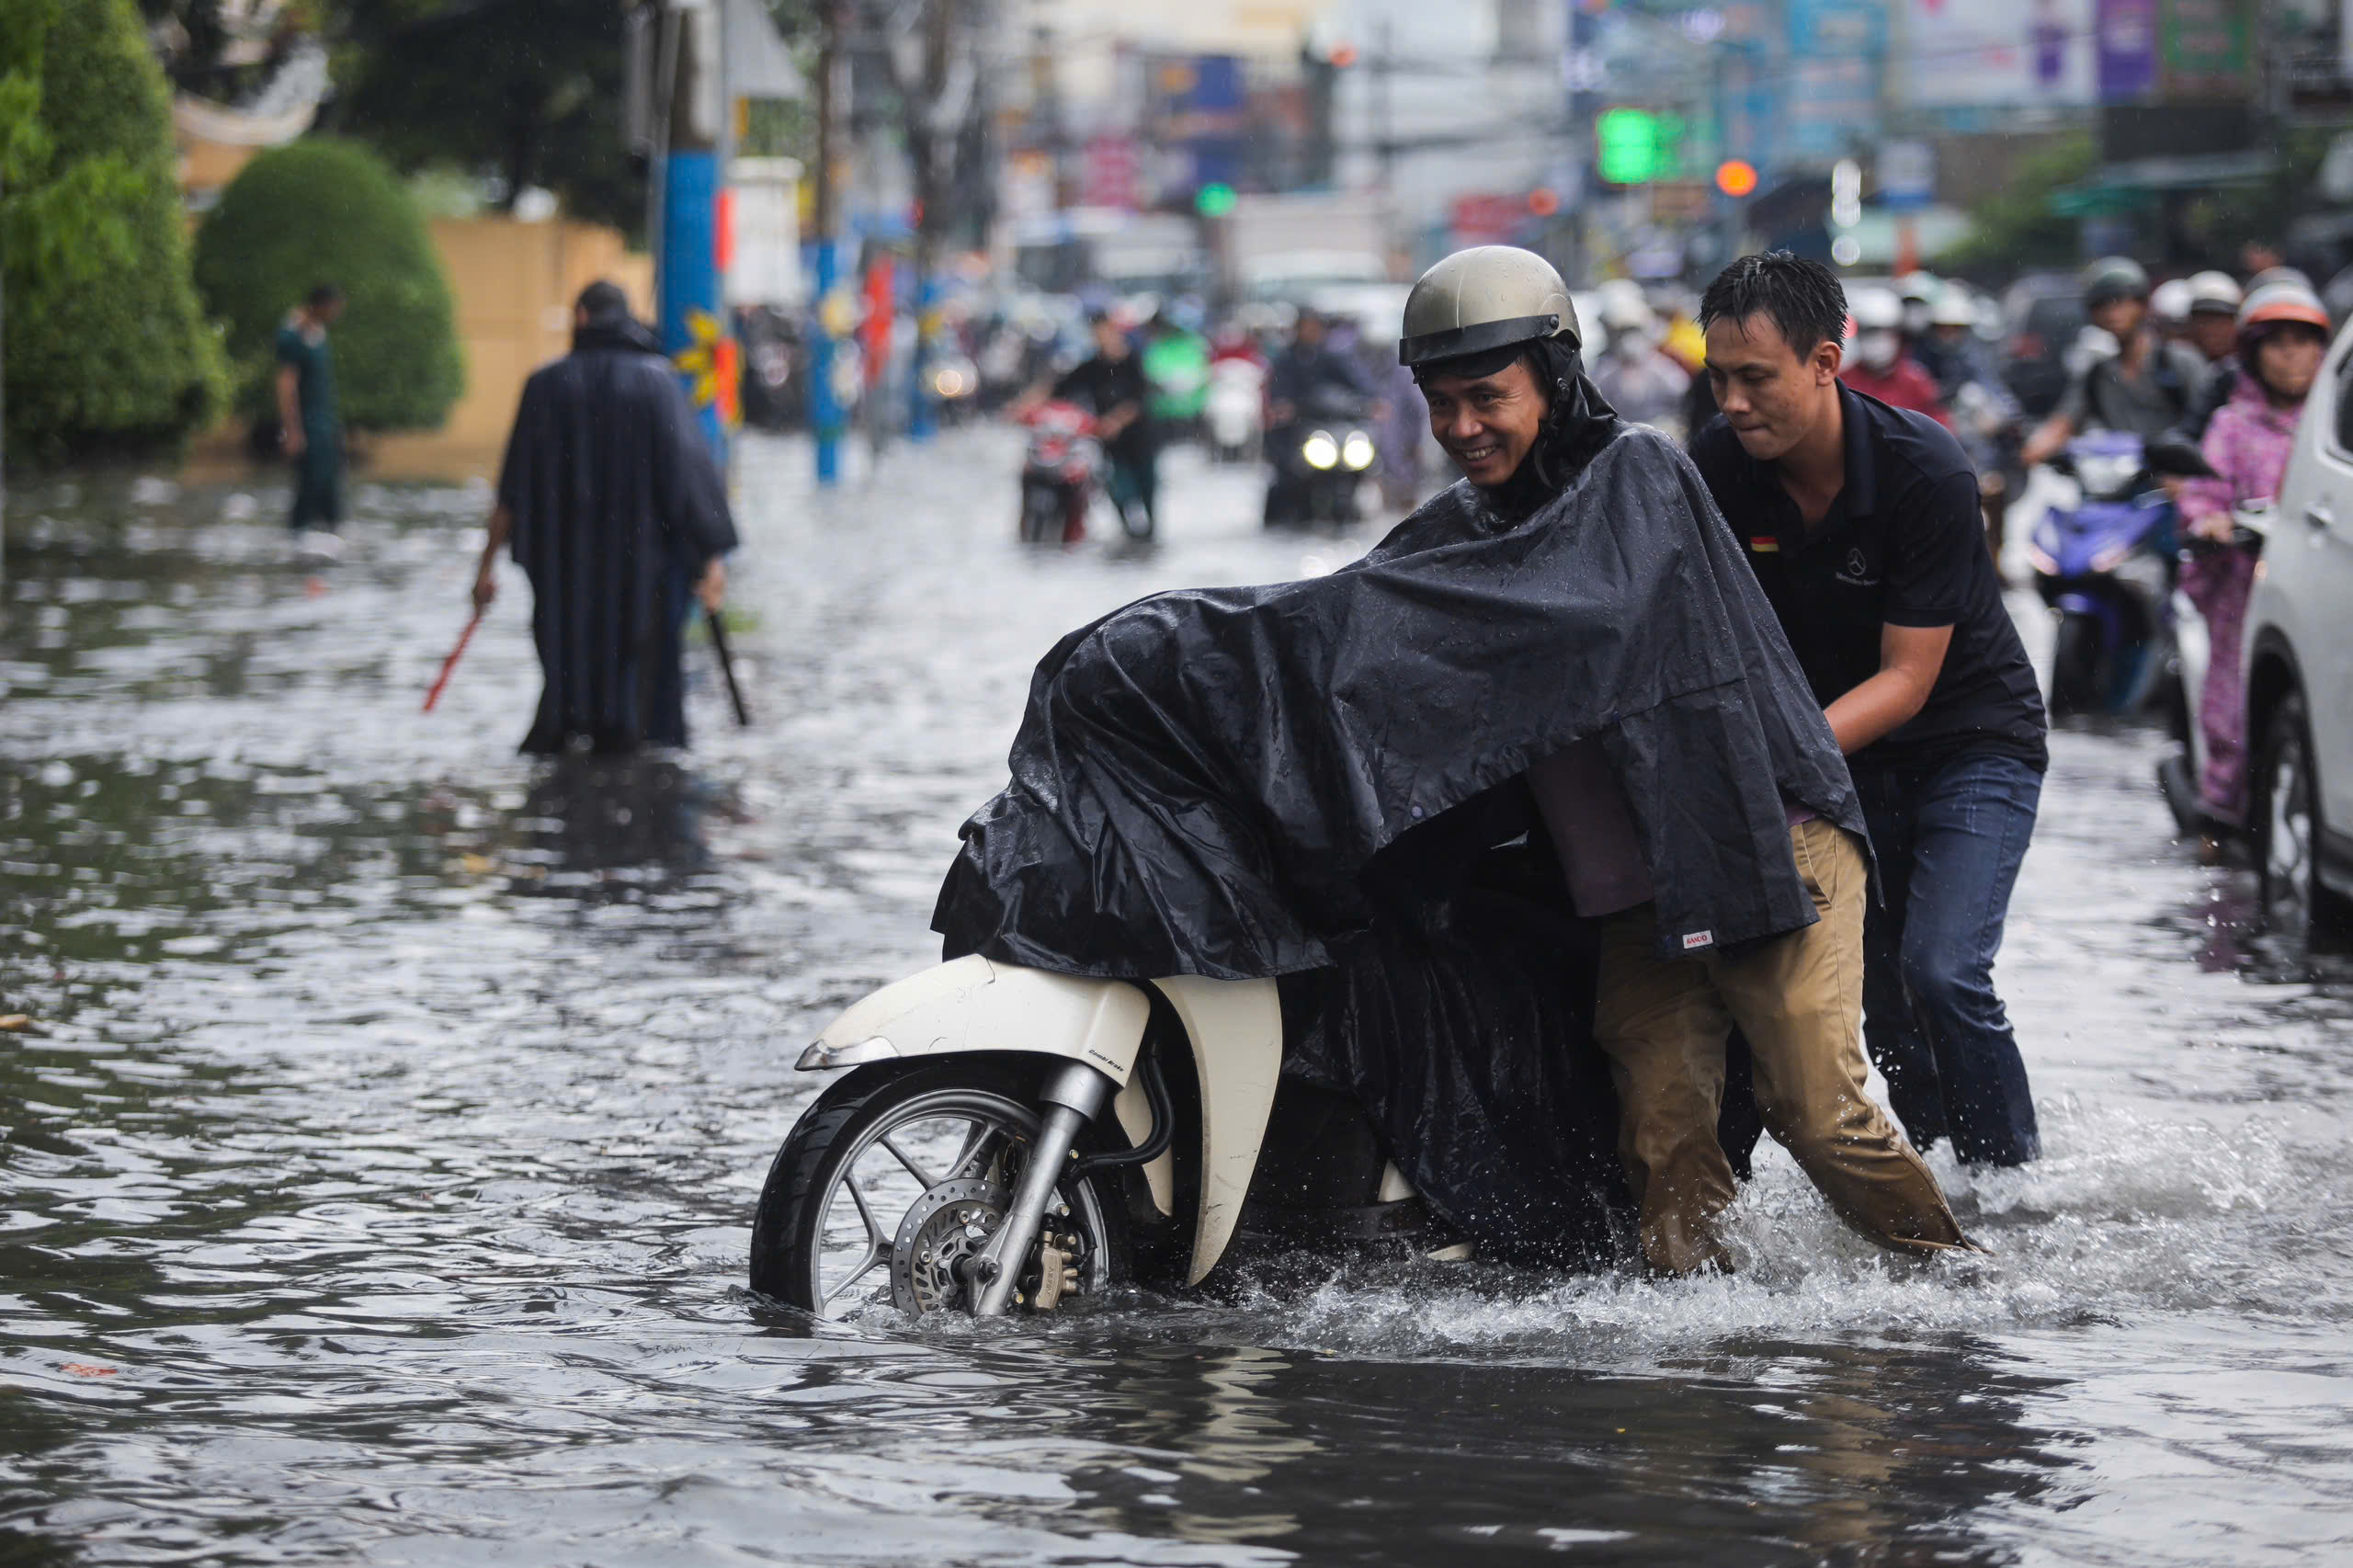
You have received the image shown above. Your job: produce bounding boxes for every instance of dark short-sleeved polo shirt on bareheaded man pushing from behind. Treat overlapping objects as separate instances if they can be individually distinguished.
[1692,386,2050,772]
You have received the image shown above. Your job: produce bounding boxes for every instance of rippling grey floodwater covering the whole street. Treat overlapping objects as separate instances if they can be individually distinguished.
[0,431,2353,1568]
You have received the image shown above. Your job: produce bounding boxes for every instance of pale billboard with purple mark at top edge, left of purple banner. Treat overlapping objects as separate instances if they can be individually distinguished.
[1904,0,2109,108]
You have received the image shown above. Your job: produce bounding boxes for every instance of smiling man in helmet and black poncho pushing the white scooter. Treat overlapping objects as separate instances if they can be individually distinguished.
[934,247,1967,1274]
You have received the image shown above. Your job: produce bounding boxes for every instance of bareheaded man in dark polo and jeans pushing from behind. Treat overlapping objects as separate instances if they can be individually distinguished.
[1692,252,2047,1165]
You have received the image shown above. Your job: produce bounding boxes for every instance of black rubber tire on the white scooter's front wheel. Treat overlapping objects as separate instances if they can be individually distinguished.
[751,1055,1134,1316]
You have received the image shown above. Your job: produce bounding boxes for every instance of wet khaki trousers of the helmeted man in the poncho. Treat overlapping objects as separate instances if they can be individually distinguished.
[1593,819,1970,1274]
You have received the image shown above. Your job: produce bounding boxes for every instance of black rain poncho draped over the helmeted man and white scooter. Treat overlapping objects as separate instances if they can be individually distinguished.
[932,415,1864,980]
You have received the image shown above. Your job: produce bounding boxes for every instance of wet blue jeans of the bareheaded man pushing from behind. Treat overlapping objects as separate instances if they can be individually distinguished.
[1854,751,2042,1165]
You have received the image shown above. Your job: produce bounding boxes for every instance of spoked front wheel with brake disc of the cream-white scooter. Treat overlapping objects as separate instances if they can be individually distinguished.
[751,1057,1131,1318]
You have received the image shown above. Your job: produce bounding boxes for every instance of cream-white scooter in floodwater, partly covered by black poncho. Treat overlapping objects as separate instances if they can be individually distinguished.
[751,956,1430,1316]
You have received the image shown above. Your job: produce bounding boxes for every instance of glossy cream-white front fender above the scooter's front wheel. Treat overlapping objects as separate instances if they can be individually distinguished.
[800,953,1153,1087]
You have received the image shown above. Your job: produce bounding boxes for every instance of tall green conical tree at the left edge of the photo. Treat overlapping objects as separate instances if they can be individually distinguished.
[0,0,222,461]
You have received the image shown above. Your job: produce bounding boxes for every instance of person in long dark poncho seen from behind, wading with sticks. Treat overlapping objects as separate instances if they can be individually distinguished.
[473,282,736,754]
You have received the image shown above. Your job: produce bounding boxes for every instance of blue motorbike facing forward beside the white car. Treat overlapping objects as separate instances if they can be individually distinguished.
[2029,431,2174,718]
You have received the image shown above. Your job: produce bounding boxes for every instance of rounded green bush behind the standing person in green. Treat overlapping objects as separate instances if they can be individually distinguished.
[195,137,466,431]
